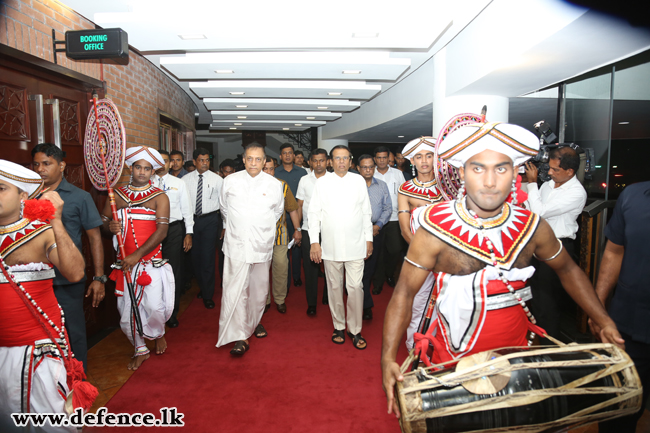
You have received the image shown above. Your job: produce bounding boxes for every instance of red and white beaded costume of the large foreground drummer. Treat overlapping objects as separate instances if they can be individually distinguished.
[415,198,540,363]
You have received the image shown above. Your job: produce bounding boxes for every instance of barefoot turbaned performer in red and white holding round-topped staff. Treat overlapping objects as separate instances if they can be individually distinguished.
[102,146,175,370]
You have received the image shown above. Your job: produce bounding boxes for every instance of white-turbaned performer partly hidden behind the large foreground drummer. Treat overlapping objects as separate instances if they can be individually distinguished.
[397,137,444,350]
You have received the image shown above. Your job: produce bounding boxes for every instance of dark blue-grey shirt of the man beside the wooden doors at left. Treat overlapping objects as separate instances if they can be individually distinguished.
[54,178,102,285]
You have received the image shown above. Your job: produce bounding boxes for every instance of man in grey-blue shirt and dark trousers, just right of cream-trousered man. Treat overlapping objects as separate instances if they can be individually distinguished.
[357,155,393,320]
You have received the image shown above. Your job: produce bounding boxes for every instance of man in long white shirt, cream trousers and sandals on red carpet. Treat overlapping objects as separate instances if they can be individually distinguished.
[308,146,373,350]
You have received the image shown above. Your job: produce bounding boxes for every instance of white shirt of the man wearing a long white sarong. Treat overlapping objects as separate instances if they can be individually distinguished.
[220,170,284,263]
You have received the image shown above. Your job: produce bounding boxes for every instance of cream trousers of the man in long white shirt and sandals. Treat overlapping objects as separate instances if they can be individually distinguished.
[323,259,364,335]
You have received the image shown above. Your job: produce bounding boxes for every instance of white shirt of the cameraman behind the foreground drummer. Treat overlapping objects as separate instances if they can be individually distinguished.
[526,176,587,239]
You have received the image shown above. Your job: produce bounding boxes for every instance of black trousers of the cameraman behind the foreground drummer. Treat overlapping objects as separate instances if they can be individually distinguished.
[530,238,575,344]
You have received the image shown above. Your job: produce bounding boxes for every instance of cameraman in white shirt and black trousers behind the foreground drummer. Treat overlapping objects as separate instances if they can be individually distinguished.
[526,146,587,344]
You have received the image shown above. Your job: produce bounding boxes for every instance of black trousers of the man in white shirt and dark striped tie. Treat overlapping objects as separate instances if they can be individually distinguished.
[191,212,221,301]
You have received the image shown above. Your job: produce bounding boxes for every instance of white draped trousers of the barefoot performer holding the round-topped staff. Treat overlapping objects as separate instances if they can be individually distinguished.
[117,263,176,354]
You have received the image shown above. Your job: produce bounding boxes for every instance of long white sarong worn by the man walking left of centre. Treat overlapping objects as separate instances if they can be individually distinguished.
[217,256,271,347]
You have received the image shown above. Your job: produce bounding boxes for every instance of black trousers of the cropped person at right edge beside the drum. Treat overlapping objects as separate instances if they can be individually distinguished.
[598,332,650,433]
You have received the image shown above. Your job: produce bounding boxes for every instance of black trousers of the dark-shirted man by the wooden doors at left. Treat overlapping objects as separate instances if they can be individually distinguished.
[54,281,88,371]
